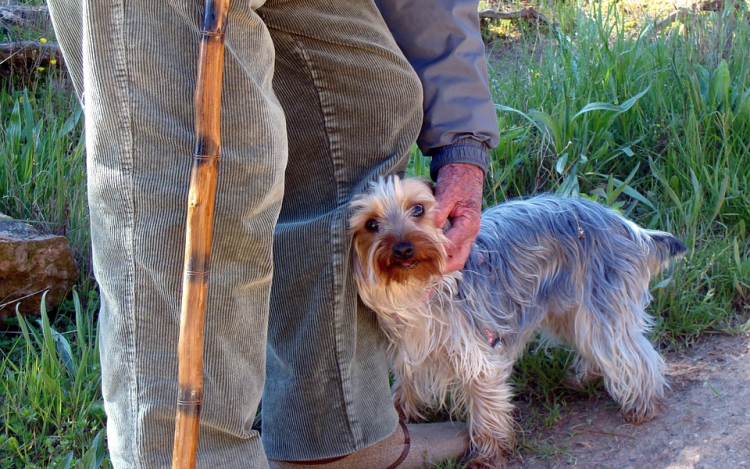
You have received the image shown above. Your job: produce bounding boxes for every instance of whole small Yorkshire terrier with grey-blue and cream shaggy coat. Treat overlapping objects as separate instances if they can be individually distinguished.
[350,176,685,467]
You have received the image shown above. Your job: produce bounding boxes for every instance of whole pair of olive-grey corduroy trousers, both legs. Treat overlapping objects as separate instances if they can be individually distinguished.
[49,0,422,469]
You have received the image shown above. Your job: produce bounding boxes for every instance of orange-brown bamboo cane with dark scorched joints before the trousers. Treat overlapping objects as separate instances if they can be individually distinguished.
[172,0,229,469]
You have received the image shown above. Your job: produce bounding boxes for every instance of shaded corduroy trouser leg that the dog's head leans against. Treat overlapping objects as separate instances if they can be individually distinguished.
[258,0,422,460]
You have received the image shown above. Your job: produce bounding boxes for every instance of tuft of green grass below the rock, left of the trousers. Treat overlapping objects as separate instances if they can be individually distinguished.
[0,292,106,469]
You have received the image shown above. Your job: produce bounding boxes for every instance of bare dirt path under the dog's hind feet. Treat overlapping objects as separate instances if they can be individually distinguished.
[511,334,750,469]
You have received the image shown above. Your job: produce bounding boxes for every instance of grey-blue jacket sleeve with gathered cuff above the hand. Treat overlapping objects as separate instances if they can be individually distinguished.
[375,0,499,179]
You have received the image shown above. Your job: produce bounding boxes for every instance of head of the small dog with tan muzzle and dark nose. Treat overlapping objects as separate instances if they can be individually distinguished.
[349,176,447,300]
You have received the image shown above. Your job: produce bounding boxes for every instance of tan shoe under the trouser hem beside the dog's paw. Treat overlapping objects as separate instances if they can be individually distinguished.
[269,422,470,469]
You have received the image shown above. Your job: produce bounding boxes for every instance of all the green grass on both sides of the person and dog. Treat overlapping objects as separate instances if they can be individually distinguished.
[0,2,750,469]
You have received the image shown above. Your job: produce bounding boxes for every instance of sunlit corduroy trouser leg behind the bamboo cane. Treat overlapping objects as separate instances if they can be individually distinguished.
[50,0,287,469]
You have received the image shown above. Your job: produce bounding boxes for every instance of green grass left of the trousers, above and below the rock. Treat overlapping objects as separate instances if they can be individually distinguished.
[0,20,98,469]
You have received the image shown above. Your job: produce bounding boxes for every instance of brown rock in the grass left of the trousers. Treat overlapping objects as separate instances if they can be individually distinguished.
[0,214,79,319]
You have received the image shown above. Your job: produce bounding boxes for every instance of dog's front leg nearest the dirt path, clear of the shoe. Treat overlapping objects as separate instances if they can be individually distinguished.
[454,344,515,467]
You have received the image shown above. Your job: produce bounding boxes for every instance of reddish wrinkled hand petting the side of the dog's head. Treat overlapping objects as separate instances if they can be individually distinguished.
[435,163,484,273]
